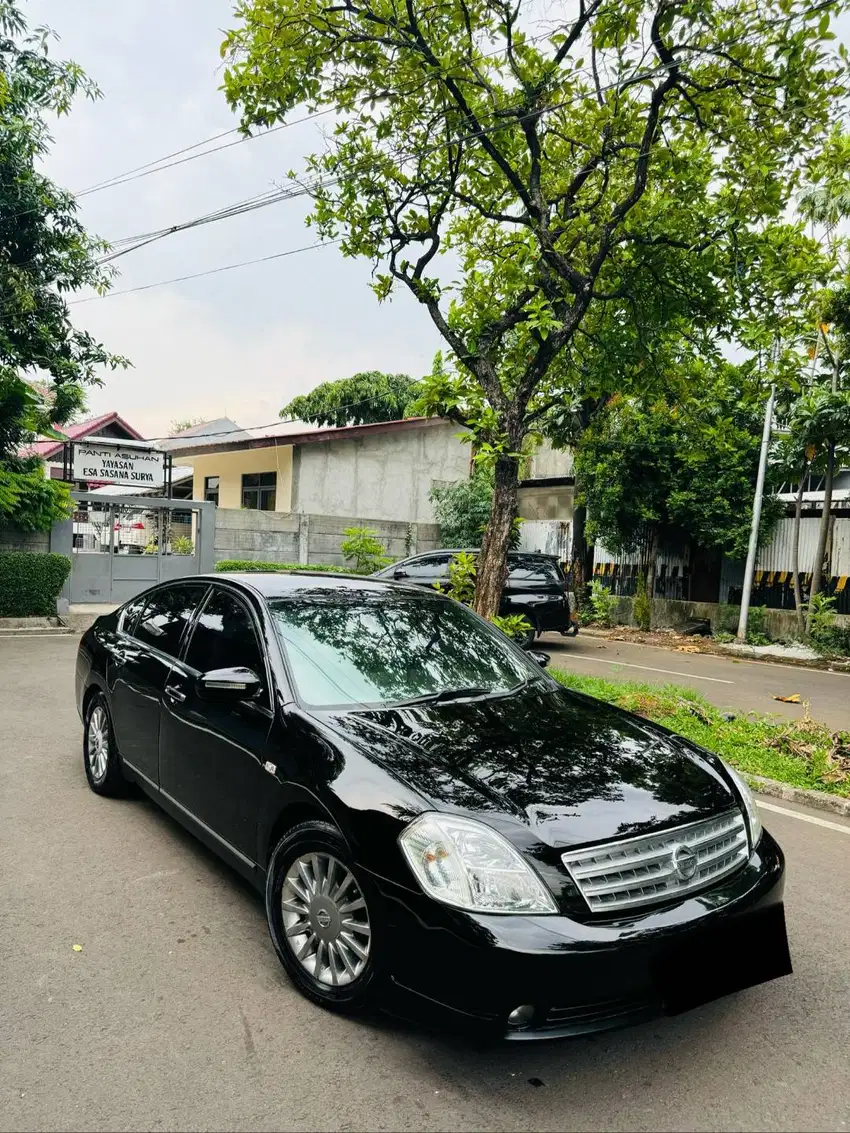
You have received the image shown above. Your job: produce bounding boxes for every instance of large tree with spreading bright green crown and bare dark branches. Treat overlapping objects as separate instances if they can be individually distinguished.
[222,0,844,616]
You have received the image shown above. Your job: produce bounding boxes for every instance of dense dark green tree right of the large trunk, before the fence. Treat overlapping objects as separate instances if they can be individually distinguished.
[576,365,780,616]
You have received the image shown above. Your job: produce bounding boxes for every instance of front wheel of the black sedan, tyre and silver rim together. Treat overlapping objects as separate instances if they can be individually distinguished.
[265,821,384,1015]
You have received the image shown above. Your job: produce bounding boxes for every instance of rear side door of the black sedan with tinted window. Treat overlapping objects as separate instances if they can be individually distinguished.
[107,582,209,785]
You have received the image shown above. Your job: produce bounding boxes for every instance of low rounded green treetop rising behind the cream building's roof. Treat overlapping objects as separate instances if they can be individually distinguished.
[280,369,419,427]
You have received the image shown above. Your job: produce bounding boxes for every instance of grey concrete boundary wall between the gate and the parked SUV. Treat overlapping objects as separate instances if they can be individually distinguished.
[215,508,440,567]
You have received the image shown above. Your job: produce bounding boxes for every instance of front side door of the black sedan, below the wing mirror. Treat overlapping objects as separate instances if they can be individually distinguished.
[160,585,278,861]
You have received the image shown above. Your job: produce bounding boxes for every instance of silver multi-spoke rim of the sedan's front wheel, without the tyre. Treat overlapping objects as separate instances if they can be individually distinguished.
[280,853,372,987]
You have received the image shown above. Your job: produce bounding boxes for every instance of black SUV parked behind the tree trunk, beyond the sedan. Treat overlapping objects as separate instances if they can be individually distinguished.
[374,550,578,648]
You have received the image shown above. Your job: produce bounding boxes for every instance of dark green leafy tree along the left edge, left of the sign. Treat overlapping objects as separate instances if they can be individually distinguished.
[0,0,124,530]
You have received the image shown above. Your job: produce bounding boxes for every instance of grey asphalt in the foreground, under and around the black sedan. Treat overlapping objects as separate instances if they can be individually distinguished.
[0,638,850,1131]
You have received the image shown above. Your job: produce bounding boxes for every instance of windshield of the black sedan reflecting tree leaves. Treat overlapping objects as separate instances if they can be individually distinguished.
[269,590,539,707]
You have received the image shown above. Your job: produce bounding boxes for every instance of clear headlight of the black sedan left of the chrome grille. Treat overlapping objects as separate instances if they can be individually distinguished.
[399,813,558,913]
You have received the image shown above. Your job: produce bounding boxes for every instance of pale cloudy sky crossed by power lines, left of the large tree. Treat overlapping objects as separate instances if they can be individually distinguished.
[30,0,440,437]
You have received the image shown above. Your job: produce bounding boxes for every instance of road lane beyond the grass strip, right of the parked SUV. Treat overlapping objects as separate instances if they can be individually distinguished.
[546,633,850,729]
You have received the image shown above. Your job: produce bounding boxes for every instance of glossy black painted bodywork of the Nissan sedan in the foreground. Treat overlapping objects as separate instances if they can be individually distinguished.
[76,573,790,1038]
